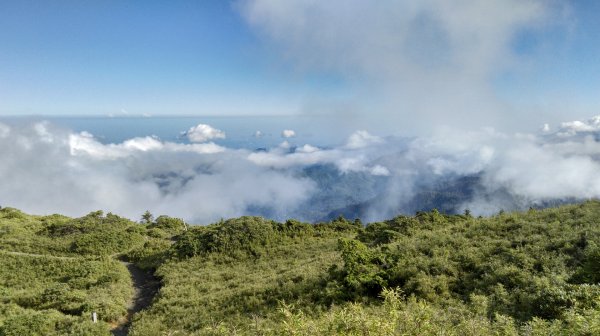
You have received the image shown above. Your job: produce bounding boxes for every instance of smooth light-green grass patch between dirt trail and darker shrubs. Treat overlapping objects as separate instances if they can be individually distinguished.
[133,232,340,335]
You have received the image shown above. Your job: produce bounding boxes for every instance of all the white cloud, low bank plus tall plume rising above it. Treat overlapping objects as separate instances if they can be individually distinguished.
[0,0,600,224]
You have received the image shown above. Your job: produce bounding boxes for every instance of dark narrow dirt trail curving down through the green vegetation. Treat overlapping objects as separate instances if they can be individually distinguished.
[111,261,160,336]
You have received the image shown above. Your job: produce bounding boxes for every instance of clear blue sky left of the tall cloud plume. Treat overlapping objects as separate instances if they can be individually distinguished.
[0,1,338,115]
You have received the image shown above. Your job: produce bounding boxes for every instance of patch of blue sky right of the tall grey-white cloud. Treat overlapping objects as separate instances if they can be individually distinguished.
[502,0,600,104]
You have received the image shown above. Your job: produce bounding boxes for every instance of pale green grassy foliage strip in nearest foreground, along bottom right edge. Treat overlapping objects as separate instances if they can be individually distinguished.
[193,289,600,336]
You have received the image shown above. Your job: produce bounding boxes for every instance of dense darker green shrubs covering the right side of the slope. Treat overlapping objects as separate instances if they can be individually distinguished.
[332,202,600,322]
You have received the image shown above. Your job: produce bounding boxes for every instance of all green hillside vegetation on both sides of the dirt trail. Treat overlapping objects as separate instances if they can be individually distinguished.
[0,201,600,335]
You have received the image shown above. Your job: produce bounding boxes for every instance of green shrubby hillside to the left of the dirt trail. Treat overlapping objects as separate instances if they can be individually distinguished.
[0,208,143,335]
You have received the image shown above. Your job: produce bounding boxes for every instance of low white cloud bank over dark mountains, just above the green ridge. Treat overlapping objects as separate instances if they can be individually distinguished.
[0,117,600,224]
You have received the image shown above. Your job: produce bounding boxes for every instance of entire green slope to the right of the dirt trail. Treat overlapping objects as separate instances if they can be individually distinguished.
[133,202,600,335]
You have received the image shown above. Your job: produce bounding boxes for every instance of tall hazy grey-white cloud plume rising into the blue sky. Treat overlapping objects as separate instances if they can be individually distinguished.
[238,0,567,134]
